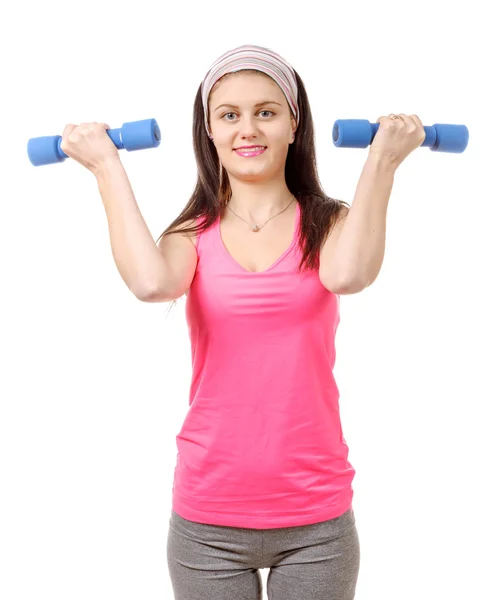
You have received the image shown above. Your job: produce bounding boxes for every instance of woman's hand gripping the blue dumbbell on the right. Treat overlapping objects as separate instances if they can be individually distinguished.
[369,113,426,168]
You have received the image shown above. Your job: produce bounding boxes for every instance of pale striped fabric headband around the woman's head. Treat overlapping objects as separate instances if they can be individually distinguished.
[202,44,300,139]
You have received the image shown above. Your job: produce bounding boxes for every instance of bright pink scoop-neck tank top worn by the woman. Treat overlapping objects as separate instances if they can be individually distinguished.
[172,204,355,529]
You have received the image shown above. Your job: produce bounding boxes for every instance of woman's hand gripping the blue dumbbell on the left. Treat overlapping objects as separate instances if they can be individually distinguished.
[61,122,119,174]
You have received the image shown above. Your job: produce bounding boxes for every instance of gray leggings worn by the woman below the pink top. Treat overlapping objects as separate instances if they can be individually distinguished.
[167,508,360,600]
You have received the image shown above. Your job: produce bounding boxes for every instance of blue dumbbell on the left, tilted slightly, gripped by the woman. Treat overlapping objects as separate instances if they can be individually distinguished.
[27,119,160,167]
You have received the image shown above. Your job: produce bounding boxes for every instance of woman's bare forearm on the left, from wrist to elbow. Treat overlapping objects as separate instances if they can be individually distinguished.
[95,159,166,298]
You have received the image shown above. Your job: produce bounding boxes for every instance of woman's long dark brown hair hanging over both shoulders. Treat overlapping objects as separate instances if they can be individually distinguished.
[156,69,350,308]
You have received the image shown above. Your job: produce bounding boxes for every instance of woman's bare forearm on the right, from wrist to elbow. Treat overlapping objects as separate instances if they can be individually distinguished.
[335,155,396,288]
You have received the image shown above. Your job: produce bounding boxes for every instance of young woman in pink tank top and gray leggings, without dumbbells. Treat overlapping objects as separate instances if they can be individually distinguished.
[62,45,425,600]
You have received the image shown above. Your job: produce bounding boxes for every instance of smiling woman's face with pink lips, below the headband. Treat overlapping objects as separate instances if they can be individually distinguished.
[209,72,296,181]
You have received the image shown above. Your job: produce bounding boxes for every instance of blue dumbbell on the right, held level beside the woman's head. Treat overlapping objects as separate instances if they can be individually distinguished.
[332,119,469,153]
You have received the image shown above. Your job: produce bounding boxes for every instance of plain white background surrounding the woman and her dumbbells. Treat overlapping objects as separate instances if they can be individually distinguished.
[0,0,485,600]
